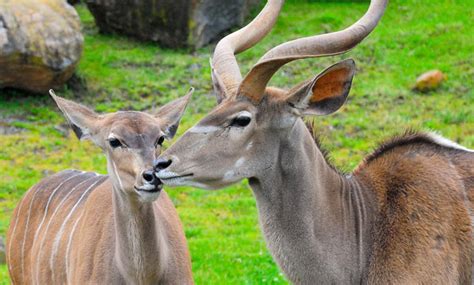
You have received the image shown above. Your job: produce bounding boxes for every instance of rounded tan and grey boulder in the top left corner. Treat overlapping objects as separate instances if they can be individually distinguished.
[0,0,84,93]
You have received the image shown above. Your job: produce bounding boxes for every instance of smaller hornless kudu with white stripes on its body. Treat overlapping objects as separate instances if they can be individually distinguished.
[7,92,193,284]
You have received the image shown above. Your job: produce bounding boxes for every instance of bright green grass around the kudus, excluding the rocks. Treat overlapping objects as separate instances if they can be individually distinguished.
[0,0,474,284]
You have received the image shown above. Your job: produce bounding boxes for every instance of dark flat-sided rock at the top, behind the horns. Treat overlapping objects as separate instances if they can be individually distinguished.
[85,0,260,48]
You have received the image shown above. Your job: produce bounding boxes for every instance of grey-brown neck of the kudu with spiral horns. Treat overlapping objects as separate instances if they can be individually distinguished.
[250,119,374,283]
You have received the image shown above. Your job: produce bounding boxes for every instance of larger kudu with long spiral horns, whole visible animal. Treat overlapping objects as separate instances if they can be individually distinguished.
[155,0,474,284]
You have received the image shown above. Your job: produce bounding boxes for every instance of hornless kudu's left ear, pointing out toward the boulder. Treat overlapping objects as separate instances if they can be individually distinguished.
[49,89,100,139]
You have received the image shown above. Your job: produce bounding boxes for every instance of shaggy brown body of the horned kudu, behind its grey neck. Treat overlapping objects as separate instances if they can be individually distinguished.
[355,132,474,284]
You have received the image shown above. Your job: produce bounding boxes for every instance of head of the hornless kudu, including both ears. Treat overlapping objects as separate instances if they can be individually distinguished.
[50,89,192,202]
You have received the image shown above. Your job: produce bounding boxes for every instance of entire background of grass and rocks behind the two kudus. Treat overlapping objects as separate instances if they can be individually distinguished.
[0,0,474,284]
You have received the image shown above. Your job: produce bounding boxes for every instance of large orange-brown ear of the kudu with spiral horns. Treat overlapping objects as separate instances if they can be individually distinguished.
[286,59,355,115]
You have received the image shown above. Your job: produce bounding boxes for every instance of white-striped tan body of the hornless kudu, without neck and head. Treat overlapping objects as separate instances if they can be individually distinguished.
[7,170,192,284]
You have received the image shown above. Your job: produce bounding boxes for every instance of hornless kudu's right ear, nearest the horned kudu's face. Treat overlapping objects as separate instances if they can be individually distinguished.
[155,88,194,139]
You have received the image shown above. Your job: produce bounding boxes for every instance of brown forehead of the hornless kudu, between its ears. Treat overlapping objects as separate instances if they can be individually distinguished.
[104,111,162,148]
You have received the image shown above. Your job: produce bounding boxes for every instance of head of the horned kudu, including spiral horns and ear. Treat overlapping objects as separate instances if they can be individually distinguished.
[155,0,387,189]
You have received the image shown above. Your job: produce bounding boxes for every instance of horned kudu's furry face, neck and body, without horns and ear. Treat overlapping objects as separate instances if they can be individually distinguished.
[157,101,474,284]
